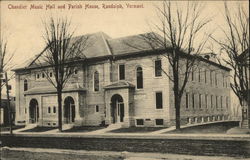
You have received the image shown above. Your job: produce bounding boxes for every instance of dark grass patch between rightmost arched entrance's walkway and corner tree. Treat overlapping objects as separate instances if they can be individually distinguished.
[109,127,166,133]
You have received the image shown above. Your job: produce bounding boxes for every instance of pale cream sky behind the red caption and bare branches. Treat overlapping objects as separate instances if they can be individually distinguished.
[0,1,249,94]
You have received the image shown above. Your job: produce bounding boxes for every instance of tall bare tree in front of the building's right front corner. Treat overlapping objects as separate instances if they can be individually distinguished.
[139,1,210,129]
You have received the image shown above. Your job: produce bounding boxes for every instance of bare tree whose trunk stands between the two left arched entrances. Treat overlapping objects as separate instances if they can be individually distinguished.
[37,17,88,131]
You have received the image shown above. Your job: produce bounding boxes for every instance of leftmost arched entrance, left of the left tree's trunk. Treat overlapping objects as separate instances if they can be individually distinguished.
[29,99,39,123]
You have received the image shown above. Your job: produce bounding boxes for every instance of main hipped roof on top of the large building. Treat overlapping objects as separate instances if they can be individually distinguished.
[14,32,230,71]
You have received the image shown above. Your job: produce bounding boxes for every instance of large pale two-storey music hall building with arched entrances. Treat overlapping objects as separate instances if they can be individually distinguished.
[14,32,230,127]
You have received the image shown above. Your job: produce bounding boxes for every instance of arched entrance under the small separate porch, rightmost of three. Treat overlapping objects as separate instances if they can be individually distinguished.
[111,94,124,123]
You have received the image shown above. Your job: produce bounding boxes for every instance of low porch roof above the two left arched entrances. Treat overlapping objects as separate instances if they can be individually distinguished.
[24,84,86,95]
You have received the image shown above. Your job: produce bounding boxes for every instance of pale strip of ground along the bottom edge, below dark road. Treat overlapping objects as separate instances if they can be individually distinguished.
[2,147,249,160]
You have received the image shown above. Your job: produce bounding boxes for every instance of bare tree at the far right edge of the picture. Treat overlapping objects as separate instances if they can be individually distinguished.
[211,2,250,126]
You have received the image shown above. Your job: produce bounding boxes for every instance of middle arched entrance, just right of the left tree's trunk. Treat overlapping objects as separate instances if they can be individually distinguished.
[64,97,75,124]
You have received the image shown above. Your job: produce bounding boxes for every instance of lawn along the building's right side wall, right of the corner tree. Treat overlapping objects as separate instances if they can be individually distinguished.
[166,122,239,134]
